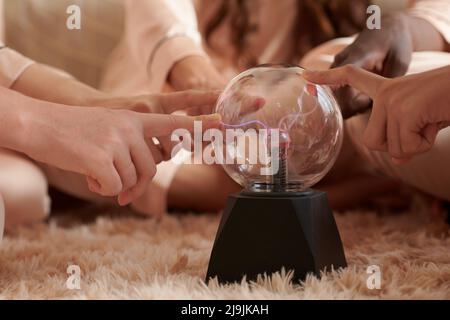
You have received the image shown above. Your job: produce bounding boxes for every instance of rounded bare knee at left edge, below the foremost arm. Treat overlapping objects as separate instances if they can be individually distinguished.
[0,149,50,229]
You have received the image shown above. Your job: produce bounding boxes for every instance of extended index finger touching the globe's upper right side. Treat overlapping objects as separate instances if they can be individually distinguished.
[303,64,386,99]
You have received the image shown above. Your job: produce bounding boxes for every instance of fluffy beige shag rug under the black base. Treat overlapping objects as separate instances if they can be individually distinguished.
[0,201,450,299]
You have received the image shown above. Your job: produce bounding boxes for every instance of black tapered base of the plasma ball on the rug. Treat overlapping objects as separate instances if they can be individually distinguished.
[206,190,347,283]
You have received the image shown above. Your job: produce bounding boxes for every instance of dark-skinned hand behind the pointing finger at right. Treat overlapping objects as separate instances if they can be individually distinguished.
[331,14,413,119]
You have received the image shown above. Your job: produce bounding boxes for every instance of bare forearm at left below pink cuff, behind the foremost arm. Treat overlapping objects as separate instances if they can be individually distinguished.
[11,63,108,106]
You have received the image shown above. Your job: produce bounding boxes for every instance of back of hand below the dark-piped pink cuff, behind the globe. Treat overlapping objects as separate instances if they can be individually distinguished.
[169,56,226,90]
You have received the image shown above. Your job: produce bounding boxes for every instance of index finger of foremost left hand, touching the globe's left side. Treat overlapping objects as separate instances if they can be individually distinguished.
[138,114,222,138]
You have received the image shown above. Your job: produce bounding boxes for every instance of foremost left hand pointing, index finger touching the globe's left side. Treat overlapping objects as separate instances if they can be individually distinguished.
[19,102,220,205]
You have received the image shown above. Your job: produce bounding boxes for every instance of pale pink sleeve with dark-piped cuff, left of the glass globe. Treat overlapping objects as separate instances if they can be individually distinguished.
[102,0,205,94]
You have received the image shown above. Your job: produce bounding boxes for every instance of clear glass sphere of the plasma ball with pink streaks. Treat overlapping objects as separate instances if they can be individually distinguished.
[215,65,343,192]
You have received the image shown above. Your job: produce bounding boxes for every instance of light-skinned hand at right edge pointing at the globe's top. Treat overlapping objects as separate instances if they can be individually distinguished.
[304,65,450,163]
